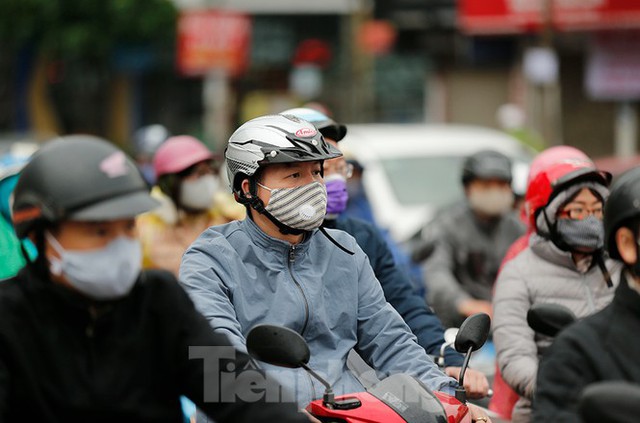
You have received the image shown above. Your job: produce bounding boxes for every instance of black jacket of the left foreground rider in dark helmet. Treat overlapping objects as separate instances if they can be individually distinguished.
[0,265,307,423]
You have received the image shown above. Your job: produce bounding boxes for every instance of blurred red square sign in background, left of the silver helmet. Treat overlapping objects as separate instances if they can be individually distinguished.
[177,10,251,76]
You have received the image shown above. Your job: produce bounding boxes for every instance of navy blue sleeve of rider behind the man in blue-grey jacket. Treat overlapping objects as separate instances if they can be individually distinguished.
[372,229,464,366]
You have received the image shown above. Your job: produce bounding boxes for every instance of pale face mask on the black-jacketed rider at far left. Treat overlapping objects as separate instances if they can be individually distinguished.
[45,232,142,300]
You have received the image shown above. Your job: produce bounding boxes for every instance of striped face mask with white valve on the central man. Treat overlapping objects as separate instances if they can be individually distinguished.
[258,182,327,231]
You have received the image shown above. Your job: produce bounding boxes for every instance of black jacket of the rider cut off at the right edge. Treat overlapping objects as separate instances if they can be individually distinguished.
[533,276,640,423]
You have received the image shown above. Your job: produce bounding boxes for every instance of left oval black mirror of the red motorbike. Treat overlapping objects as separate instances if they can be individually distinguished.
[247,324,311,368]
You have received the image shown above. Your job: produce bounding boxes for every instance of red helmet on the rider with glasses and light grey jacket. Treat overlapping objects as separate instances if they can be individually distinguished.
[525,158,611,228]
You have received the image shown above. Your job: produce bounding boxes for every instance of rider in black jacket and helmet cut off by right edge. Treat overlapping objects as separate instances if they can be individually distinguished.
[533,168,640,422]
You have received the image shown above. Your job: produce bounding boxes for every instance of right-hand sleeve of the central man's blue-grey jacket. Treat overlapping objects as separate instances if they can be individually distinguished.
[354,249,457,393]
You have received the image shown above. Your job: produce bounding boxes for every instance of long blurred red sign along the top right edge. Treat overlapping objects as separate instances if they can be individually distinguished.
[458,0,640,34]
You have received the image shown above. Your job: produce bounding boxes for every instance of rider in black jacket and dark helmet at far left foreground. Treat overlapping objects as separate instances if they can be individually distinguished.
[0,135,308,422]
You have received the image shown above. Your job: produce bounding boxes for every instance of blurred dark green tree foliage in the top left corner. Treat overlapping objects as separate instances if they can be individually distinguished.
[0,0,177,61]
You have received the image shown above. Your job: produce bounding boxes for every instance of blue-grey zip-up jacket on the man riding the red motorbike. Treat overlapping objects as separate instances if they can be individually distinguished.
[180,219,457,406]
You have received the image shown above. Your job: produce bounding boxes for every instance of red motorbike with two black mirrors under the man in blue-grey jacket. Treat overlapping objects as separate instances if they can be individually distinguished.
[247,313,491,423]
